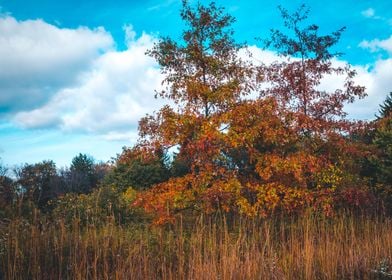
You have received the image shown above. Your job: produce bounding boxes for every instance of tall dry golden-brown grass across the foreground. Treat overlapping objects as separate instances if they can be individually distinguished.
[0,214,392,279]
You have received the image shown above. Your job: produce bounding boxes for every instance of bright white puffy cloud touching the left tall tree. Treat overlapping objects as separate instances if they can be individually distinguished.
[14,26,162,140]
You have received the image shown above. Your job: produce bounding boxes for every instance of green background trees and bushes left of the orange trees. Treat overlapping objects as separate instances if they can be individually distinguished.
[0,148,191,223]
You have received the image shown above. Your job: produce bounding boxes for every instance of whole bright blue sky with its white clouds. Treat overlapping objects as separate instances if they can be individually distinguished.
[0,0,392,167]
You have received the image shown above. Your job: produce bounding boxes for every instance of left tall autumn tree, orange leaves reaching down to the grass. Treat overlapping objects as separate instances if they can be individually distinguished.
[135,1,260,223]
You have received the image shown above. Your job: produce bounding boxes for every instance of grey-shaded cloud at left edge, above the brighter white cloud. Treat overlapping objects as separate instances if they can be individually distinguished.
[0,16,114,113]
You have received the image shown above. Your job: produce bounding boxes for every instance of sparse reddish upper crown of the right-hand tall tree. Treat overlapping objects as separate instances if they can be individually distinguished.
[260,5,365,122]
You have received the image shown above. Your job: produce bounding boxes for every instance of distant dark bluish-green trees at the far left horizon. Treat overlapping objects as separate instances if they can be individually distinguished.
[0,154,104,215]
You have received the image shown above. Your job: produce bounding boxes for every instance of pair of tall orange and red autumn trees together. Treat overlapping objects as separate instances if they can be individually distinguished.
[135,1,370,223]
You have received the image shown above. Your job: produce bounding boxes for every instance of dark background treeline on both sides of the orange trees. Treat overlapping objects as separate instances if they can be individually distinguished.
[0,93,392,224]
